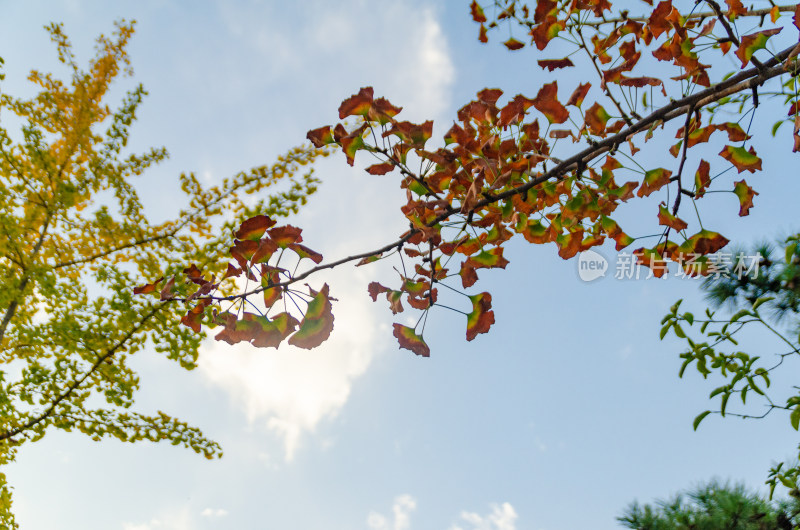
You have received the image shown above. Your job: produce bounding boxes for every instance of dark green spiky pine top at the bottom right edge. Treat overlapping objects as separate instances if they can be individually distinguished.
[617,481,800,530]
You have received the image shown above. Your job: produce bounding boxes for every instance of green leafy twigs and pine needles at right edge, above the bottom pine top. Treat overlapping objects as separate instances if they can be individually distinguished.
[661,234,800,498]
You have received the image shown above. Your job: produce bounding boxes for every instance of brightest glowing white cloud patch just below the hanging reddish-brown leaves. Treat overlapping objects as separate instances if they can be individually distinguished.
[199,270,385,460]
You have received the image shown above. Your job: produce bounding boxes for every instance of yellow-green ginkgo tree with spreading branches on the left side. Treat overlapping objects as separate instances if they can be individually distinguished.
[0,21,325,528]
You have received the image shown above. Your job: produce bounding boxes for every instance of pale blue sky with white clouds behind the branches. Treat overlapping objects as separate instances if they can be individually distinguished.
[0,0,800,530]
